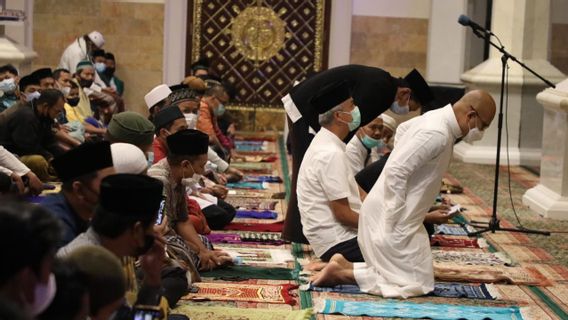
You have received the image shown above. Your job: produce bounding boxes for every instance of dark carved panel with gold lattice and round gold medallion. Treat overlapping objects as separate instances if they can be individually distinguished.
[186,0,330,111]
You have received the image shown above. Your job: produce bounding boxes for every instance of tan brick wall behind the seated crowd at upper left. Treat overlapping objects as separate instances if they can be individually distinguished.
[33,0,164,113]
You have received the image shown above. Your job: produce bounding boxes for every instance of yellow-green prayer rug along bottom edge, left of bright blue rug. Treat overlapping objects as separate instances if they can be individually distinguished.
[171,305,312,320]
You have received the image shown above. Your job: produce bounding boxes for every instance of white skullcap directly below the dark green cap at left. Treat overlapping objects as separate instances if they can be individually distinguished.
[110,142,148,174]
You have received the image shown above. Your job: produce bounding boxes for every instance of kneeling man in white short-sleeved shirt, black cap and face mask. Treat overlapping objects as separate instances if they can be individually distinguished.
[297,83,363,262]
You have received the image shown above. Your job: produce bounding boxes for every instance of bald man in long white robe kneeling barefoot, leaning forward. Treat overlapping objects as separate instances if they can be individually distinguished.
[312,90,495,298]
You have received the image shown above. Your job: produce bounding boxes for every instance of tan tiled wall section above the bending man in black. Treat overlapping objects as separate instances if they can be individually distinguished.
[350,15,428,76]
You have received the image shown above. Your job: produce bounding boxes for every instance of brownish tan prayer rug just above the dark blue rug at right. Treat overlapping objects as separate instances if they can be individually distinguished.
[434,262,550,286]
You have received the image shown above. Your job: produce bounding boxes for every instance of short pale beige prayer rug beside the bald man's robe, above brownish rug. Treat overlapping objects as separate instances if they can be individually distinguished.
[432,250,511,266]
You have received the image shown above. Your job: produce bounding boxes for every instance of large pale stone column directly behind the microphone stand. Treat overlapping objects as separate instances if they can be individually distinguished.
[454,0,565,165]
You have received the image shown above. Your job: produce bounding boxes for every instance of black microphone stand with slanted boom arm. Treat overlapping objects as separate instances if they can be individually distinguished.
[468,28,555,236]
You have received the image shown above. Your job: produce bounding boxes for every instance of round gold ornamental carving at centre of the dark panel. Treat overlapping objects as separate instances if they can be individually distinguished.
[231,6,286,62]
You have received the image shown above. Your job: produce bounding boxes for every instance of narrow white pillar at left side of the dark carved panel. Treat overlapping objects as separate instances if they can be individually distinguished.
[162,0,187,85]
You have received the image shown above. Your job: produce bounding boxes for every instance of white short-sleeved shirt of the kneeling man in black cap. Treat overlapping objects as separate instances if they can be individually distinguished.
[296,127,361,257]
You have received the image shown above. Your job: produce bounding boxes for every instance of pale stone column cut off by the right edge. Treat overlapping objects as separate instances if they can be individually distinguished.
[523,79,568,220]
